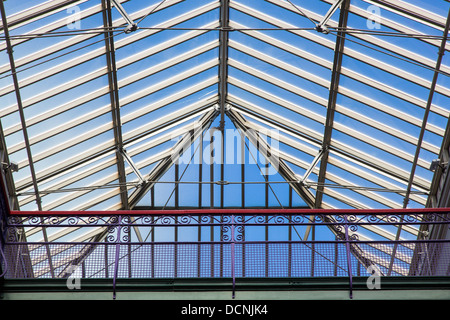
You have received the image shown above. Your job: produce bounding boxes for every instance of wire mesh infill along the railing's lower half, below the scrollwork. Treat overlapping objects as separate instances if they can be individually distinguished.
[3,241,450,279]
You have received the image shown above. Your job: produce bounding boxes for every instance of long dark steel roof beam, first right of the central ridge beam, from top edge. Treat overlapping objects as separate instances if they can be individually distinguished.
[314,0,350,208]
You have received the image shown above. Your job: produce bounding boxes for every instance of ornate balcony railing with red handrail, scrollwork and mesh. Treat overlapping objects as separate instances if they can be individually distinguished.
[2,210,450,298]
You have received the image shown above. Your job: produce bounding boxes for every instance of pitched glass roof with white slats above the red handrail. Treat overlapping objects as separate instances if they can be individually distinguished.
[0,0,450,248]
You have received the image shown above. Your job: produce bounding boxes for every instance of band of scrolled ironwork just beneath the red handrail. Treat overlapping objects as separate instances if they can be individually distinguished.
[6,211,450,242]
